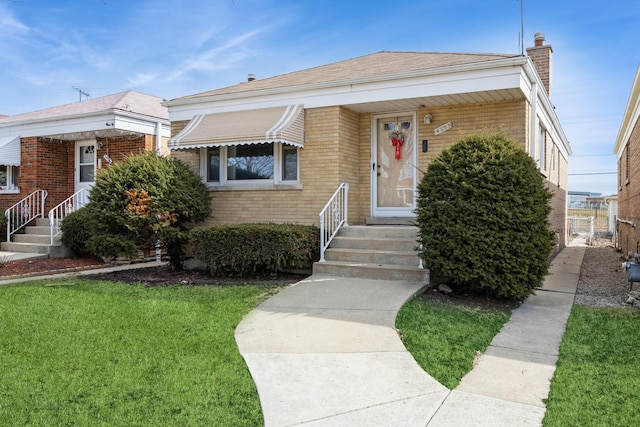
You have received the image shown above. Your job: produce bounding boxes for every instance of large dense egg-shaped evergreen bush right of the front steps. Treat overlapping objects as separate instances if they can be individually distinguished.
[417,134,554,299]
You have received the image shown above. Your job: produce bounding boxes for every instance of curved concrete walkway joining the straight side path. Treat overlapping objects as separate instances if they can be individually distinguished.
[236,242,584,427]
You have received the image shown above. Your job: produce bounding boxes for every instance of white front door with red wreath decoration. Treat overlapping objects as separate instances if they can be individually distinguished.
[371,113,417,217]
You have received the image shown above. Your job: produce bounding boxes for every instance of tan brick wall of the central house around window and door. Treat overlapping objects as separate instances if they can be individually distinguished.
[166,100,566,239]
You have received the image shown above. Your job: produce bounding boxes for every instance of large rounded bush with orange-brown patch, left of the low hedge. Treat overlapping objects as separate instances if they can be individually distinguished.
[63,152,211,268]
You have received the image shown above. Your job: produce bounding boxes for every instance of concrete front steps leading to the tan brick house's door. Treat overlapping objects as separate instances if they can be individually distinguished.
[313,225,429,283]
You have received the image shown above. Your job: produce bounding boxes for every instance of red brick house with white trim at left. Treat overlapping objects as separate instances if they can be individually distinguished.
[0,91,170,251]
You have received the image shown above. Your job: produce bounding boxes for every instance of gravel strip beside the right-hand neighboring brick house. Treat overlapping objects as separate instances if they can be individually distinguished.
[574,239,640,307]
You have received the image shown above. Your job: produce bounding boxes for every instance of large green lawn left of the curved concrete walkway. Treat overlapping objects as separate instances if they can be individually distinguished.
[0,279,282,426]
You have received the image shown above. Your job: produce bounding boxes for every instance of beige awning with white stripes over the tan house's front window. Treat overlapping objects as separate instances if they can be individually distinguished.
[169,105,304,150]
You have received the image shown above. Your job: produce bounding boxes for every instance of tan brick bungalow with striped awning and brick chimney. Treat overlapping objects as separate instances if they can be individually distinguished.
[164,34,571,254]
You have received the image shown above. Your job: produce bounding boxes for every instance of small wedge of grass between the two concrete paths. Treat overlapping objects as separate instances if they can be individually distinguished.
[396,297,511,389]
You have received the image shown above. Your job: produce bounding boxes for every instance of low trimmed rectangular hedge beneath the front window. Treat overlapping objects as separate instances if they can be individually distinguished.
[189,224,320,275]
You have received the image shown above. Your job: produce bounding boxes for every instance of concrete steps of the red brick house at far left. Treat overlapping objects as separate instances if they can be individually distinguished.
[0,218,65,258]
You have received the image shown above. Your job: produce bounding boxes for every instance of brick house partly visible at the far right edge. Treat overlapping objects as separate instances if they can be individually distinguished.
[613,67,640,255]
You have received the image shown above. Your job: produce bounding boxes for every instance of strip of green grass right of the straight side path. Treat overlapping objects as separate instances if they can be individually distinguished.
[543,306,640,427]
